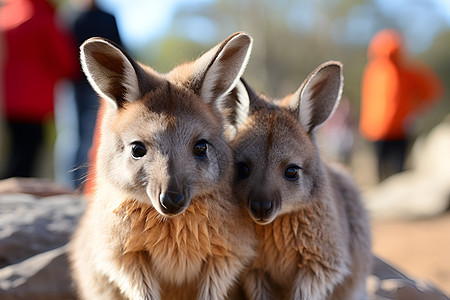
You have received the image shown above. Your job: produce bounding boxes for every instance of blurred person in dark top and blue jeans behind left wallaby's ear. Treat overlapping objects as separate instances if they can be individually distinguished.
[68,0,122,187]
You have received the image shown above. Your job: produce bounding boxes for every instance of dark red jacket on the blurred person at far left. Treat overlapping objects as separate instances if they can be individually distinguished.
[0,0,79,123]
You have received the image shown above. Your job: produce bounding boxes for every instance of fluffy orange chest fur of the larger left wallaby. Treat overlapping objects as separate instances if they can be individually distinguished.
[114,201,228,285]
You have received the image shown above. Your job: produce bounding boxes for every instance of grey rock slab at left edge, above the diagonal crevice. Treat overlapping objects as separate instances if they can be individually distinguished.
[0,194,85,267]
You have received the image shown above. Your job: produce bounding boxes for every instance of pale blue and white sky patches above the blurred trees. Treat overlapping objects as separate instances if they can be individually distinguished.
[97,0,450,53]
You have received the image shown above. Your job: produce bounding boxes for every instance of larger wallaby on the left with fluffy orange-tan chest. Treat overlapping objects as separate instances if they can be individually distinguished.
[70,32,257,300]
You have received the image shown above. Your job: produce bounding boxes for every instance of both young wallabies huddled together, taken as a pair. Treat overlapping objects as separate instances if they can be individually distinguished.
[70,29,371,299]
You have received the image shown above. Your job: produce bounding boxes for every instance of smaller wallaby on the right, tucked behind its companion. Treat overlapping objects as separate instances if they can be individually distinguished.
[231,62,372,300]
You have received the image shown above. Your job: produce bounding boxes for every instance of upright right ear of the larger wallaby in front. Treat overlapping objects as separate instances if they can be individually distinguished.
[193,32,253,111]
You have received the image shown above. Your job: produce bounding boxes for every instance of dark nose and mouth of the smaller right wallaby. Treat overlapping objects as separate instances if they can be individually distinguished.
[248,191,280,224]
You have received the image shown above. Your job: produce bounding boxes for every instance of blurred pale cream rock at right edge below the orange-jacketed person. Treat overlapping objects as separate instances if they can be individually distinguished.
[364,118,450,219]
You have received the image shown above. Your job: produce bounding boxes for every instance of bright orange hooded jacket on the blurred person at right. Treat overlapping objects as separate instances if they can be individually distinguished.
[360,30,443,141]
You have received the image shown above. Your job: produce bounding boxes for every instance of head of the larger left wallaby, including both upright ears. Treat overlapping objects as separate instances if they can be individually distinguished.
[81,32,252,216]
